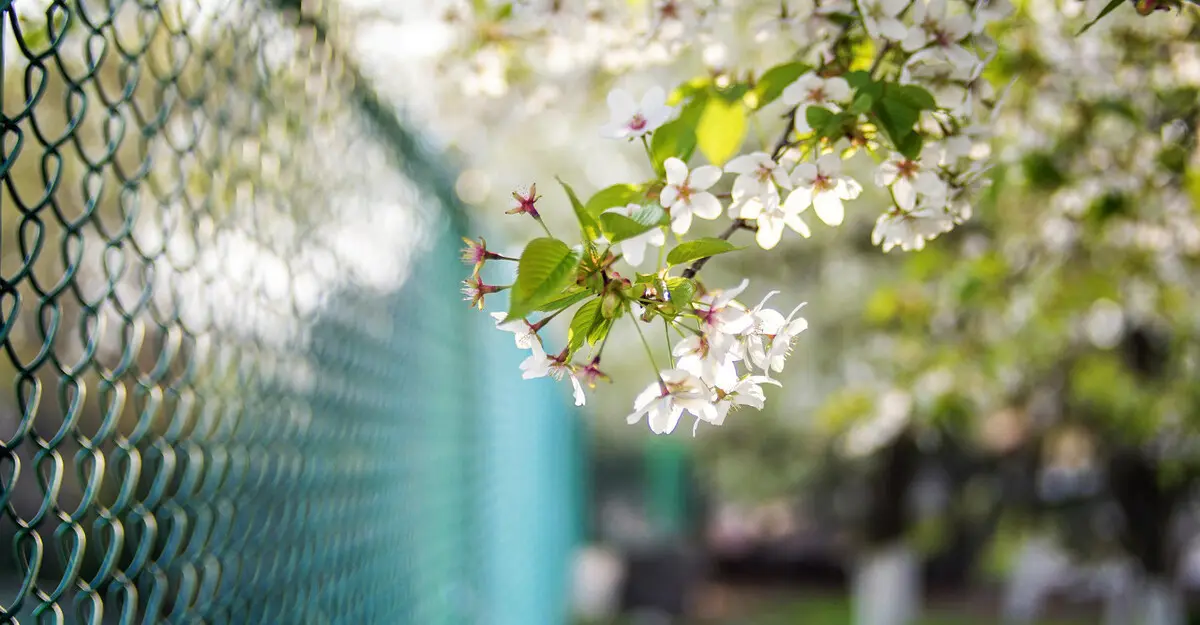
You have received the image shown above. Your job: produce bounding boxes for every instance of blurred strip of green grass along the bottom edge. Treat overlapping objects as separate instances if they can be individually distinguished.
[580,597,1084,625]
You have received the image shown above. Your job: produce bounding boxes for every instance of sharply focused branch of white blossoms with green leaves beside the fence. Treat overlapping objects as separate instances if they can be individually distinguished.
[451,0,1022,433]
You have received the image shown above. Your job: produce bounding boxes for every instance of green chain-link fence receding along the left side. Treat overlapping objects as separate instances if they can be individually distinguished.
[0,0,571,625]
